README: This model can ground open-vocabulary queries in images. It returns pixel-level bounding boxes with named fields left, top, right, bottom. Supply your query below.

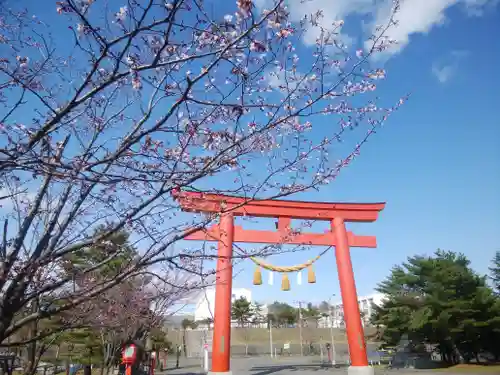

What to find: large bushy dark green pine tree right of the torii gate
left=372, top=250, right=498, bottom=363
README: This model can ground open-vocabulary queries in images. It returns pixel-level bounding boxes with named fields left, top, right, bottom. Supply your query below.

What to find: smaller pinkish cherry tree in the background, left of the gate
left=61, top=275, right=178, bottom=374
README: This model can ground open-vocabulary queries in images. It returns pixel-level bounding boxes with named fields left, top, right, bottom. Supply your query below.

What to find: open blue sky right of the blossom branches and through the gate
left=2, top=0, right=500, bottom=310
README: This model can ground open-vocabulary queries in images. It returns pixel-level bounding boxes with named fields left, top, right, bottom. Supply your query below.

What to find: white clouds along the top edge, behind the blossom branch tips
left=255, top=0, right=500, bottom=57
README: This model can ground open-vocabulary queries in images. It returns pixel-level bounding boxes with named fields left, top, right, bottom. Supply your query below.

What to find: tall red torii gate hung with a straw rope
left=173, top=191, right=385, bottom=375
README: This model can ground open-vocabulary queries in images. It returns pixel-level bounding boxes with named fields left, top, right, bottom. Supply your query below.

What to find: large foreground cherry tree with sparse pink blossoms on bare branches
left=0, top=0, right=405, bottom=352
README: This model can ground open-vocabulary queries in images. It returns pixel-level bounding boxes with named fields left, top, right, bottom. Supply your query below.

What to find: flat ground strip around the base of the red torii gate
left=162, top=356, right=500, bottom=375
